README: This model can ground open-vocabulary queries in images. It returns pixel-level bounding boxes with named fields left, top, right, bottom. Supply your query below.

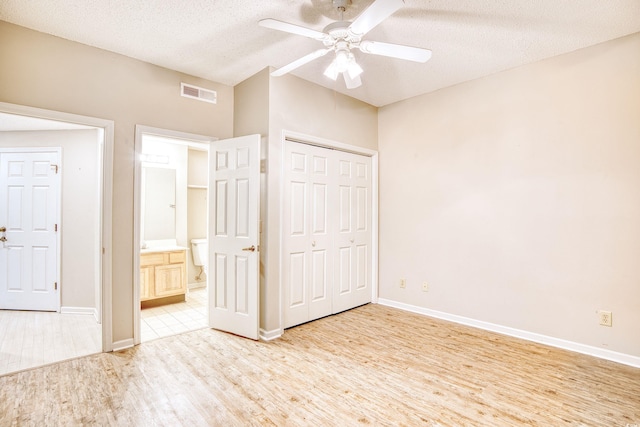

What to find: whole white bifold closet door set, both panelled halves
left=282, top=141, right=372, bottom=328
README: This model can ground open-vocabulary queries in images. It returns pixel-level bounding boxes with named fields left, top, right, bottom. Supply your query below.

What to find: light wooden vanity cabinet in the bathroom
left=140, top=250, right=187, bottom=307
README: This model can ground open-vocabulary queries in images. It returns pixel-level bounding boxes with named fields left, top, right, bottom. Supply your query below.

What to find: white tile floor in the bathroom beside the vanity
left=140, top=288, right=208, bottom=342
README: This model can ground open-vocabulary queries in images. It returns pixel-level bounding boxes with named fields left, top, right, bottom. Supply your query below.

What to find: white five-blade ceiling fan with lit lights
left=258, top=0, right=431, bottom=89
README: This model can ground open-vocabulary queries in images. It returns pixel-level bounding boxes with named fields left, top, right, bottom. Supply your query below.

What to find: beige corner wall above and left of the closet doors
left=235, top=69, right=378, bottom=332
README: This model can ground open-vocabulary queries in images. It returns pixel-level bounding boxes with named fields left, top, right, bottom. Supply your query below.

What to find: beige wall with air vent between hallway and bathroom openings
left=0, top=21, right=233, bottom=342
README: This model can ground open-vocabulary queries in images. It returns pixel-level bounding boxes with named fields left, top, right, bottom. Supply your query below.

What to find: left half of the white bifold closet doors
left=282, top=141, right=335, bottom=328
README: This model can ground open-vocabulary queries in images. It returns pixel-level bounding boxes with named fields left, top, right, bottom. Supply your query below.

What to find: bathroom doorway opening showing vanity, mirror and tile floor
left=134, top=126, right=215, bottom=344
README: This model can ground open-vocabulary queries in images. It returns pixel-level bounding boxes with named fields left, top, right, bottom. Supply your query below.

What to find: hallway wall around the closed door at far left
left=0, top=130, right=100, bottom=310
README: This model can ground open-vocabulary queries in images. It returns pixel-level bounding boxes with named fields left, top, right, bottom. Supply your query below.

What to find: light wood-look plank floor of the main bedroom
left=0, top=304, right=640, bottom=427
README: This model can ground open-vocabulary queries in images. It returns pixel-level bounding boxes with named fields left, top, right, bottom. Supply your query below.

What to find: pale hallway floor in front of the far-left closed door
left=0, top=310, right=102, bottom=375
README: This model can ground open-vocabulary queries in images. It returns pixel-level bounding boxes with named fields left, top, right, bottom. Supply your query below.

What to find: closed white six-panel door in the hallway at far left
left=0, top=148, right=61, bottom=311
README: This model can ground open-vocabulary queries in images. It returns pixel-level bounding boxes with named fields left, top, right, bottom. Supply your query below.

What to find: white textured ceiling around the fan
left=0, top=0, right=640, bottom=106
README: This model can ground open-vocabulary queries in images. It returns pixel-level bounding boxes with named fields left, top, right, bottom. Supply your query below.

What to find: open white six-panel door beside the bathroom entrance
left=208, top=135, right=260, bottom=340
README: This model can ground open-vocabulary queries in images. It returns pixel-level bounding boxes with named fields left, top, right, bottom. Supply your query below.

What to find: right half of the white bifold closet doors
left=333, top=151, right=373, bottom=313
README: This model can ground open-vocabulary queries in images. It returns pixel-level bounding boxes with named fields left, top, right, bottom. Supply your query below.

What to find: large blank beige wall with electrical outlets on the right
left=379, top=34, right=640, bottom=356
